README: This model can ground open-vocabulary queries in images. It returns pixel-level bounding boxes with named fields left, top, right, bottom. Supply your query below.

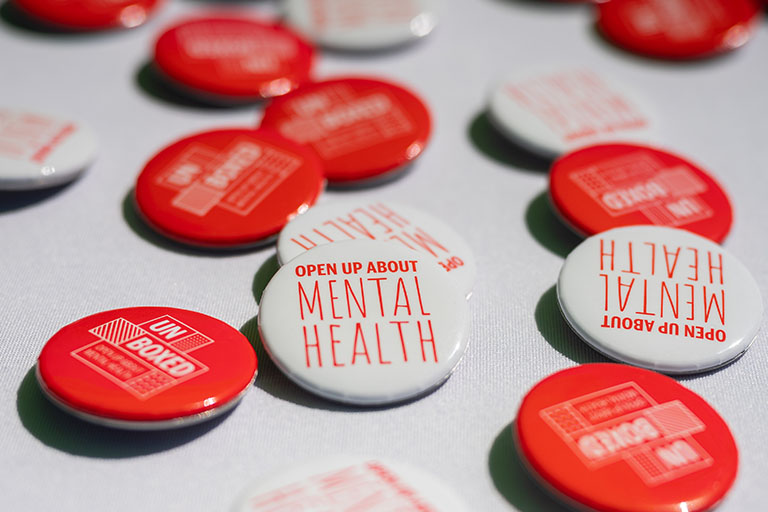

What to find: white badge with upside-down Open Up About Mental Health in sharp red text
left=557, top=226, right=763, bottom=374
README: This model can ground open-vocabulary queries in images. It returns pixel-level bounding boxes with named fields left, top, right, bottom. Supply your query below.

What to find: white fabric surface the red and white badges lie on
left=0, top=0, right=768, bottom=512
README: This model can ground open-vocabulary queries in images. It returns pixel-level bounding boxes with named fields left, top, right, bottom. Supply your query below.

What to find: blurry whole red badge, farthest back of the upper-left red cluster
left=154, top=17, right=314, bottom=100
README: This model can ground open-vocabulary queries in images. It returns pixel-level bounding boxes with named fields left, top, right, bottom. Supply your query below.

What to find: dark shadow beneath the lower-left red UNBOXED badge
left=16, top=367, right=226, bottom=459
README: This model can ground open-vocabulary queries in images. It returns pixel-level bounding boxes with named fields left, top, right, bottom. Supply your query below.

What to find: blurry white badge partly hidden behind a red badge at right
left=488, top=69, right=657, bottom=158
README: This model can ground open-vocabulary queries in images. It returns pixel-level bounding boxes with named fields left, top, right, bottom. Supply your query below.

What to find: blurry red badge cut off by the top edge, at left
left=14, top=0, right=164, bottom=30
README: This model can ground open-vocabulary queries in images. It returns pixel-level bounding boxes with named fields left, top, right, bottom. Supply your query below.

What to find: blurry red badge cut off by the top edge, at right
left=597, top=0, right=760, bottom=59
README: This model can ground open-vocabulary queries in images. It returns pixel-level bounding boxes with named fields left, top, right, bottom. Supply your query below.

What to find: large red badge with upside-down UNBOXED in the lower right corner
left=514, top=364, right=738, bottom=512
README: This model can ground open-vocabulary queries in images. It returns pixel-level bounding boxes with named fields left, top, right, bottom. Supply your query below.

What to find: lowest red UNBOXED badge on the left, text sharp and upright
left=37, top=307, right=256, bottom=430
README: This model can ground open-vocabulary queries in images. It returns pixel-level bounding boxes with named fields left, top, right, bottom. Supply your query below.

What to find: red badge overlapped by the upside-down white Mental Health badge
left=549, top=144, right=733, bottom=243
